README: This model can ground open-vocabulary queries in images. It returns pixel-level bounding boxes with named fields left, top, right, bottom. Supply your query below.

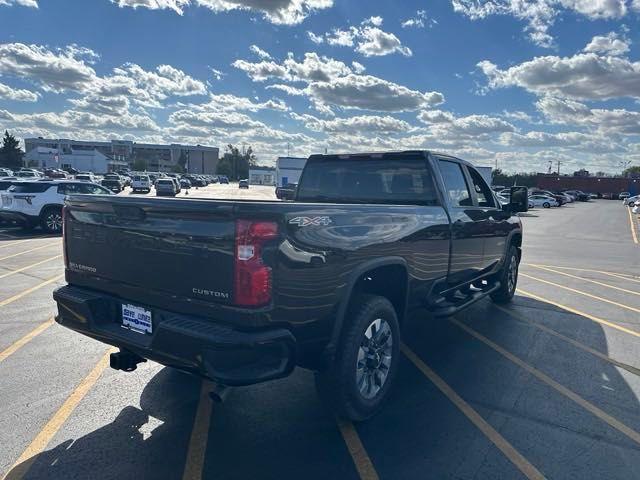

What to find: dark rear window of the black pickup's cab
left=297, top=155, right=438, bottom=205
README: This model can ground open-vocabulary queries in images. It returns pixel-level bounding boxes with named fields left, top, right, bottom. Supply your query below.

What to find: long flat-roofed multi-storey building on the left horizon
left=24, top=137, right=220, bottom=174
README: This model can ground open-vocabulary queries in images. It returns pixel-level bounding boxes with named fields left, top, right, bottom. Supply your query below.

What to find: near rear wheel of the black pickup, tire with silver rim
left=315, top=295, right=400, bottom=422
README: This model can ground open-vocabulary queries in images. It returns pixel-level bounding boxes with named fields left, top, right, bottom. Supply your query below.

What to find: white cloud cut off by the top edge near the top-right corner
left=451, top=0, right=638, bottom=47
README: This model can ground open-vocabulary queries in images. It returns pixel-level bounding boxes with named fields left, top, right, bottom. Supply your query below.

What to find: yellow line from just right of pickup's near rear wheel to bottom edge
left=400, top=344, right=545, bottom=479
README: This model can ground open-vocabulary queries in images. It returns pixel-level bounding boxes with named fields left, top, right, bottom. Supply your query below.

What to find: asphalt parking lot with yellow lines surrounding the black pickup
left=0, top=189, right=640, bottom=480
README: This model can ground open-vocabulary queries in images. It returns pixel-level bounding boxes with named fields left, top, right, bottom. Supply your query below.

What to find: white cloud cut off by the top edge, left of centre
left=116, top=0, right=333, bottom=25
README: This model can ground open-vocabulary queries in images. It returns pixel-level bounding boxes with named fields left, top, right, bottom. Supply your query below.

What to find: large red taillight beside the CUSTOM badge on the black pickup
left=234, top=220, right=278, bottom=307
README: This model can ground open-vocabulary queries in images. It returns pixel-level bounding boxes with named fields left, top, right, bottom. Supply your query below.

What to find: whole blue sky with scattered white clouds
left=0, top=0, right=640, bottom=172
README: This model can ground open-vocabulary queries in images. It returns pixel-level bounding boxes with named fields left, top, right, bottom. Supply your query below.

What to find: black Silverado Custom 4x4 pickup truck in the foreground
left=54, top=151, right=528, bottom=420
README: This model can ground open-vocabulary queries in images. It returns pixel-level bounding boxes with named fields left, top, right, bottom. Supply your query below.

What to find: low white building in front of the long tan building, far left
left=23, top=147, right=128, bottom=173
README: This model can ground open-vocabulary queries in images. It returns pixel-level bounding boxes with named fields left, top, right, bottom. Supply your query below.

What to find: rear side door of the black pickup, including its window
left=435, top=157, right=484, bottom=284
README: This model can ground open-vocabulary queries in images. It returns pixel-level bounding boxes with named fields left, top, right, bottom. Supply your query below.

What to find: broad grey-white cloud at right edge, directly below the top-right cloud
left=478, top=53, right=640, bottom=100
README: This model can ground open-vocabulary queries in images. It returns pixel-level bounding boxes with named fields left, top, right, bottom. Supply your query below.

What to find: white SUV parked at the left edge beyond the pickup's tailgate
left=0, top=181, right=111, bottom=233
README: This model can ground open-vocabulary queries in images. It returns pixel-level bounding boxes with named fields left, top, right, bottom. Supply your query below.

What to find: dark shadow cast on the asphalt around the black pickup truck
left=7, top=297, right=640, bottom=480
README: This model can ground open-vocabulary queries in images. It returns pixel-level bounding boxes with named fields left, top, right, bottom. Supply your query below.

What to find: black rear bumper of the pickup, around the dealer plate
left=53, top=286, right=296, bottom=385
